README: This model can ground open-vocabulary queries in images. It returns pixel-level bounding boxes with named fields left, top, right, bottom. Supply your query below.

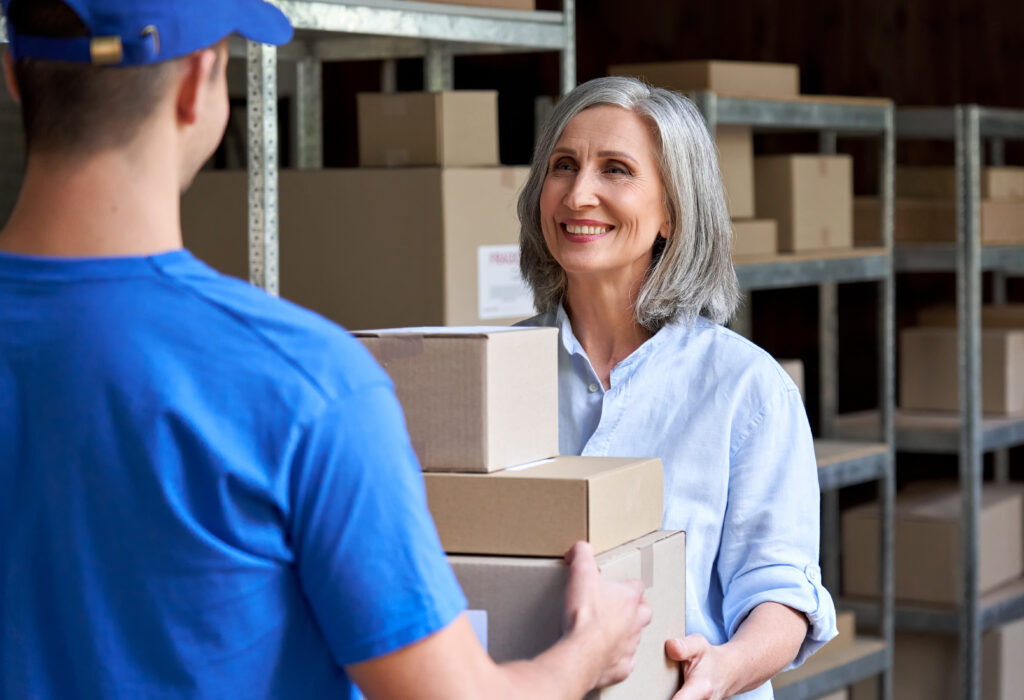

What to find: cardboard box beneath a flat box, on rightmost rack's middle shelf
left=899, top=327, right=1024, bottom=415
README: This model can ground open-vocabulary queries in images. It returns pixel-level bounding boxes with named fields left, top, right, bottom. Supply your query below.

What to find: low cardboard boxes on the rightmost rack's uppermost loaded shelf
left=854, top=167, right=1024, bottom=245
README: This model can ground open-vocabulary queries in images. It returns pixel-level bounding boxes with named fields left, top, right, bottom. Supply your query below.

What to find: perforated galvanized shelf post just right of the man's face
left=246, top=41, right=279, bottom=296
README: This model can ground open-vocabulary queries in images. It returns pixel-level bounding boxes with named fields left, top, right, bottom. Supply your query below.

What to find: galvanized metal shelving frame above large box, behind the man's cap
left=232, top=0, right=575, bottom=294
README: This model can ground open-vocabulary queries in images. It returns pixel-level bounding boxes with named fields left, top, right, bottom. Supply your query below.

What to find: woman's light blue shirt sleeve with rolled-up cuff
left=718, top=386, right=837, bottom=666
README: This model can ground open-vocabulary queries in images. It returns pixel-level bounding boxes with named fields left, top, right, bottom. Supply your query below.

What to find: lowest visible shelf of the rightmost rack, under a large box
left=840, top=578, right=1024, bottom=635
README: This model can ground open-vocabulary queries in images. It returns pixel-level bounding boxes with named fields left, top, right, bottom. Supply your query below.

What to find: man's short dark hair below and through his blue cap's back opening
left=7, top=0, right=176, bottom=156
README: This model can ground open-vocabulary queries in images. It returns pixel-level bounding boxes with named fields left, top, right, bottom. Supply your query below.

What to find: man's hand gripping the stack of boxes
left=565, top=542, right=651, bottom=688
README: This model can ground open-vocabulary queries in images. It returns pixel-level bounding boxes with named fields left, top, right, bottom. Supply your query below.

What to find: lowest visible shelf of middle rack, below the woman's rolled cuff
left=771, top=636, right=889, bottom=700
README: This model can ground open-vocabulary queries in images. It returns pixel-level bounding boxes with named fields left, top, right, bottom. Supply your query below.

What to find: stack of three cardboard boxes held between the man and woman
left=355, top=327, right=686, bottom=700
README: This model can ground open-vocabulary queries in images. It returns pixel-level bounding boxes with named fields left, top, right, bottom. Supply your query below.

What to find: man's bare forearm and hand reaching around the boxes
left=346, top=542, right=651, bottom=700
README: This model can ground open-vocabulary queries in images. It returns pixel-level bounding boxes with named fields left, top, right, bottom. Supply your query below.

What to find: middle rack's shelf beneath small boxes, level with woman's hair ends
left=734, top=248, right=891, bottom=290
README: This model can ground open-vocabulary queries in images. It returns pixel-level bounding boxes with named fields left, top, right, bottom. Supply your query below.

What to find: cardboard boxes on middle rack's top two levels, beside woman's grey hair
left=609, top=60, right=853, bottom=256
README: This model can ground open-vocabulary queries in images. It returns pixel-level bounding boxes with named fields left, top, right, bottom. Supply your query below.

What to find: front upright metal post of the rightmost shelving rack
left=955, top=105, right=982, bottom=700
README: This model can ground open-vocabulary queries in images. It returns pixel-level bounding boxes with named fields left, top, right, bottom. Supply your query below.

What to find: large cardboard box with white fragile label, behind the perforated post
left=182, top=168, right=535, bottom=329
